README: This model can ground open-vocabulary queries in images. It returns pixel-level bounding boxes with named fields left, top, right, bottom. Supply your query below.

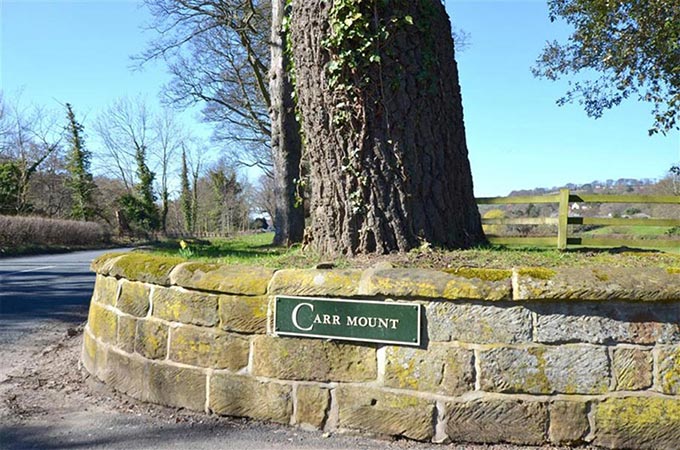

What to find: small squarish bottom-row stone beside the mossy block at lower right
left=548, top=401, right=590, bottom=445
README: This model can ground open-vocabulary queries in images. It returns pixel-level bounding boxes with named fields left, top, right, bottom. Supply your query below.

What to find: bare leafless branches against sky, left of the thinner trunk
left=136, top=0, right=272, bottom=175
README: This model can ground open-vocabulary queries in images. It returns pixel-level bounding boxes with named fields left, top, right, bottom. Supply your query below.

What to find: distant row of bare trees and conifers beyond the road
left=0, top=94, right=271, bottom=237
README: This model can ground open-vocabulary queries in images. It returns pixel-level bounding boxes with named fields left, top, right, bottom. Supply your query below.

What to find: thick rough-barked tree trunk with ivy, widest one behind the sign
left=291, top=0, right=484, bottom=254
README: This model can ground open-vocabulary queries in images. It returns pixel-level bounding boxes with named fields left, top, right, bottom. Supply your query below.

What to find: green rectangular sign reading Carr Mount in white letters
left=274, top=296, right=421, bottom=346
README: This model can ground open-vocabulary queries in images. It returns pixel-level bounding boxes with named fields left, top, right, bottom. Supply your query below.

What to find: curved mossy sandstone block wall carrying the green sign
left=83, top=254, right=680, bottom=450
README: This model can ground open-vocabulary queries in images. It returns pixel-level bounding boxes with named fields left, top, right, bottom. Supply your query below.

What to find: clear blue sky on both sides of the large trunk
left=0, top=0, right=680, bottom=196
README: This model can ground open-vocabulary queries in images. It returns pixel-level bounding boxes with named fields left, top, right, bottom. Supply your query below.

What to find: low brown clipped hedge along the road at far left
left=0, top=216, right=108, bottom=251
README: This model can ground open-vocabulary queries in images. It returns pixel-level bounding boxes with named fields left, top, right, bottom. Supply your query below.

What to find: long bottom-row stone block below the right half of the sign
left=336, top=386, right=436, bottom=441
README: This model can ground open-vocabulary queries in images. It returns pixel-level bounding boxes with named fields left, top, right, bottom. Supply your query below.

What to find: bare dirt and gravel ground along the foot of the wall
left=0, top=321, right=596, bottom=450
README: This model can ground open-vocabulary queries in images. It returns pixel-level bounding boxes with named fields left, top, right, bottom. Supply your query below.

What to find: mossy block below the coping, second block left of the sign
left=151, top=287, right=219, bottom=327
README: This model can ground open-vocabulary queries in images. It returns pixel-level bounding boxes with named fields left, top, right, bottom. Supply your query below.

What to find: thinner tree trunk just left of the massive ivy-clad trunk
left=269, top=0, right=305, bottom=246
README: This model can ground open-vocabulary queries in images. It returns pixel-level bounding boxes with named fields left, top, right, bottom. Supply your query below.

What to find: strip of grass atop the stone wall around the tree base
left=147, top=233, right=680, bottom=269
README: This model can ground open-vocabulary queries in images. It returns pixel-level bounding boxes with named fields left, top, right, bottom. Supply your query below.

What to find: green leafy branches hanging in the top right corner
left=533, top=0, right=680, bottom=135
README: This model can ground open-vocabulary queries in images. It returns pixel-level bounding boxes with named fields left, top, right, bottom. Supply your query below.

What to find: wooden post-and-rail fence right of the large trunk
left=477, top=189, right=680, bottom=250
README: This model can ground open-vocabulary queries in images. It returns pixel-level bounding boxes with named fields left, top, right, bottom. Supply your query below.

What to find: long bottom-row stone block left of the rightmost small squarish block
left=444, top=400, right=548, bottom=445
